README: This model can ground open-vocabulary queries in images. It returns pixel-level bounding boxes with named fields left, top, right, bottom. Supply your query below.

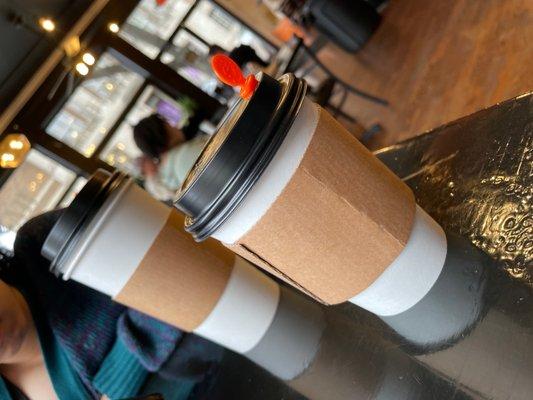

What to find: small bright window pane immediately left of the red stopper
left=161, top=30, right=218, bottom=95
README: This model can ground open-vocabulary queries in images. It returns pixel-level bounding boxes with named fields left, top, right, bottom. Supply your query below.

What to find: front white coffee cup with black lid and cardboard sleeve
left=175, top=74, right=447, bottom=316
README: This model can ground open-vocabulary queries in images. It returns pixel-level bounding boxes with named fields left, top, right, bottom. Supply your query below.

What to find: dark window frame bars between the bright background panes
left=0, top=0, right=277, bottom=180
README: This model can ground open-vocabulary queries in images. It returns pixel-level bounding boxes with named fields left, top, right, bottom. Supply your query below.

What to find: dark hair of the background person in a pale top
left=133, top=114, right=169, bottom=159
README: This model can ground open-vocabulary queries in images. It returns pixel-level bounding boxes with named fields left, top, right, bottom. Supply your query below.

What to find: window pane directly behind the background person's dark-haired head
left=100, top=86, right=195, bottom=176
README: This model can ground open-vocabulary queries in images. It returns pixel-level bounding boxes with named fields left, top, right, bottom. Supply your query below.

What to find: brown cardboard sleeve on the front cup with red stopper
left=229, top=104, right=415, bottom=304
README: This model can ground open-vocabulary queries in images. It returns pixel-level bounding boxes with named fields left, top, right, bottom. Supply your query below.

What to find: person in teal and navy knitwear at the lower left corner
left=0, top=211, right=222, bottom=400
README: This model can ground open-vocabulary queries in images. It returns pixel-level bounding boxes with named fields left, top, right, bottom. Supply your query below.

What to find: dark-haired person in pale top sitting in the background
left=133, top=114, right=209, bottom=201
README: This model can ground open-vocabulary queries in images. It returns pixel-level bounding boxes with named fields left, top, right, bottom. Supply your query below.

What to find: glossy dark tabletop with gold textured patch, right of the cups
left=210, top=94, right=533, bottom=400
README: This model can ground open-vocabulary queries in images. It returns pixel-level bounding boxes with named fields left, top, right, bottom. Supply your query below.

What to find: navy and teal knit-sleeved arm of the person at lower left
left=15, top=210, right=182, bottom=398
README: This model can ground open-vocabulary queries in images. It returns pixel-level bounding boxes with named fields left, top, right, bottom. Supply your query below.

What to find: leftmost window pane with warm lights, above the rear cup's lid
left=0, top=149, right=76, bottom=250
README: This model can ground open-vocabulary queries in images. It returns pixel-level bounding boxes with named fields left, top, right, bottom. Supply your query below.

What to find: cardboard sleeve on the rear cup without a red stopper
left=115, top=210, right=235, bottom=332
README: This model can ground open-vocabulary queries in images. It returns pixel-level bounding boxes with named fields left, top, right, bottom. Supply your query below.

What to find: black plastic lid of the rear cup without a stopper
left=41, top=169, right=127, bottom=275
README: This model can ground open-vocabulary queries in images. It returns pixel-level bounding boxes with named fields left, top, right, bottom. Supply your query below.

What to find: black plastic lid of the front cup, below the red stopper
left=175, top=74, right=307, bottom=241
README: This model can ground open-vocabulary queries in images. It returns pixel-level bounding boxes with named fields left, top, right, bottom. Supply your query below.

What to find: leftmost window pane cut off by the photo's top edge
left=119, top=0, right=194, bottom=58
